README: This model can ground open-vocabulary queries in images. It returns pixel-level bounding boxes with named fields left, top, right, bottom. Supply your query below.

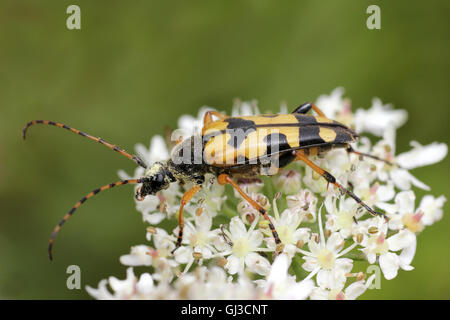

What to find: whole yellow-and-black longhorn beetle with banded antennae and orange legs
left=23, top=103, right=387, bottom=259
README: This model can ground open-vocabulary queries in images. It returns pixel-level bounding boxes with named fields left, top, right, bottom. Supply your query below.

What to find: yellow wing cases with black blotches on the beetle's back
left=203, top=113, right=357, bottom=166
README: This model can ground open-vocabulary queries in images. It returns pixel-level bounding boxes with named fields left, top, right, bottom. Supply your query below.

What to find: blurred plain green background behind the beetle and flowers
left=0, top=0, right=450, bottom=299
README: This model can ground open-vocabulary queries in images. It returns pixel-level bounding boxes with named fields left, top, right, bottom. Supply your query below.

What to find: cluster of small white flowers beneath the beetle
left=87, top=88, right=447, bottom=299
